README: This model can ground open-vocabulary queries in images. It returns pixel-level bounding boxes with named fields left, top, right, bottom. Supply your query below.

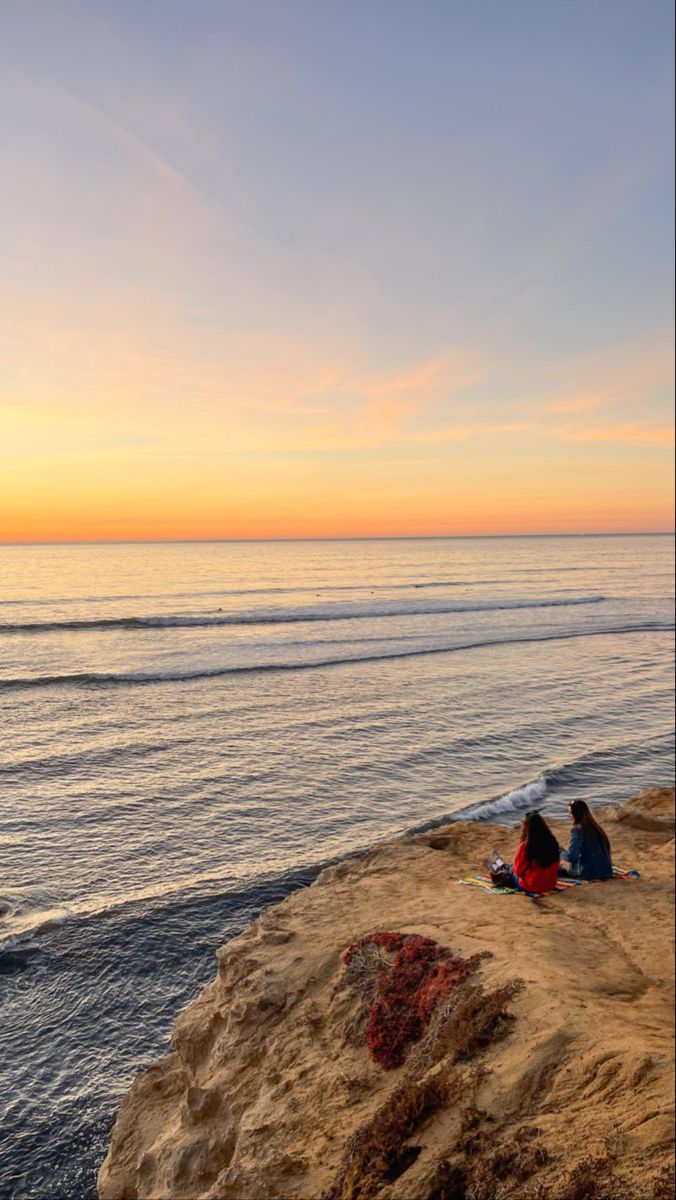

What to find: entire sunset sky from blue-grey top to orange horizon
left=0, top=0, right=674, bottom=541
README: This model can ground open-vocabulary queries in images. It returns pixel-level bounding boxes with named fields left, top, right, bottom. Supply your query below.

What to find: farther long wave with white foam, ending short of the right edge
left=0, top=584, right=605, bottom=634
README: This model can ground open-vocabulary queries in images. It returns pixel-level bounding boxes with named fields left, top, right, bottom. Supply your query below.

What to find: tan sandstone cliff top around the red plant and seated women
left=98, top=788, right=674, bottom=1200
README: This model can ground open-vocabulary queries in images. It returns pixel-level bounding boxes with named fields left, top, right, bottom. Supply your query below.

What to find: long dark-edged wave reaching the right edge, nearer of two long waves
left=0, top=622, right=674, bottom=691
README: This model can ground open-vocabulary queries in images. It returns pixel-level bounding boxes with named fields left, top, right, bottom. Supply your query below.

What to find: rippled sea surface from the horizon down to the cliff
left=0, top=536, right=674, bottom=1200
